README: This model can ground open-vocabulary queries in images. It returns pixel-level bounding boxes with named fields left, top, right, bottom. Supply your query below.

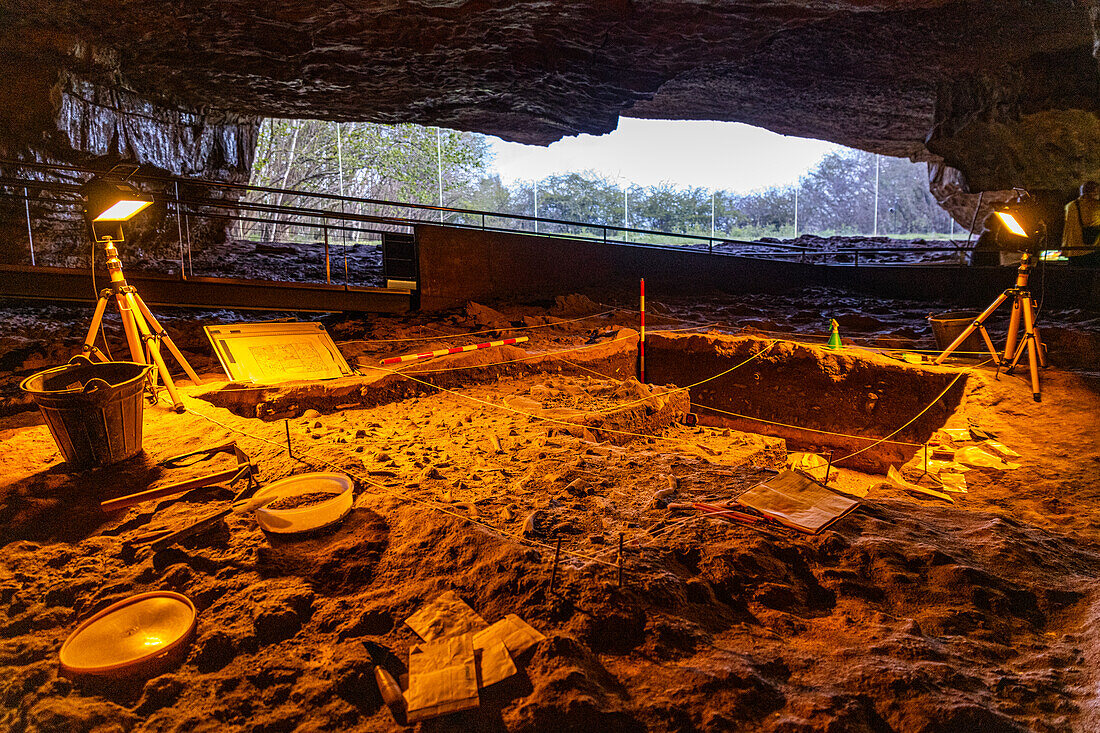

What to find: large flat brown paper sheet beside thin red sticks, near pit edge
left=737, top=471, right=859, bottom=534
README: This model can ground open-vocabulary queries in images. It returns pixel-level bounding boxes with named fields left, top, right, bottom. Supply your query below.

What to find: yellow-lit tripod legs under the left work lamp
left=80, top=237, right=200, bottom=413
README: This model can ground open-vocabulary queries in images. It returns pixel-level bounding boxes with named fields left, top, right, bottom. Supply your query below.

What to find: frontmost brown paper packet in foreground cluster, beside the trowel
left=405, top=633, right=481, bottom=723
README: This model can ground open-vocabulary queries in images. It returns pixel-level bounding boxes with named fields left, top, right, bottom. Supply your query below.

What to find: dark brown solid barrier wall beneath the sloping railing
left=417, top=225, right=1100, bottom=310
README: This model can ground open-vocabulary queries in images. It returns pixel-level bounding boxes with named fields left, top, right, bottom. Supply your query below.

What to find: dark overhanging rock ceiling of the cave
left=0, top=0, right=1100, bottom=190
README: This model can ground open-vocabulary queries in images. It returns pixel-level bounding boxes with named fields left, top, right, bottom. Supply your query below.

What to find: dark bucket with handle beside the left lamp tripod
left=19, top=357, right=153, bottom=469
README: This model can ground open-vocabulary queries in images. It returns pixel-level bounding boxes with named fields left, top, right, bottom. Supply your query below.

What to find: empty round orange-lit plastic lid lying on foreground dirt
left=61, top=591, right=197, bottom=677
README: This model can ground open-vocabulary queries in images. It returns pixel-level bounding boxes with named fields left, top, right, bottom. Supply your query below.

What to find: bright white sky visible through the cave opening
left=488, top=118, right=845, bottom=193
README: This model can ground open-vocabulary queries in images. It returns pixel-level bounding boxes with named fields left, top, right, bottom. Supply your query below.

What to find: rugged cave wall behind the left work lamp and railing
left=0, top=52, right=259, bottom=272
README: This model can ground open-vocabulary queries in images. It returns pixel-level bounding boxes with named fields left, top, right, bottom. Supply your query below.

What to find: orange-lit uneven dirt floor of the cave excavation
left=0, top=293, right=1100, bottom=731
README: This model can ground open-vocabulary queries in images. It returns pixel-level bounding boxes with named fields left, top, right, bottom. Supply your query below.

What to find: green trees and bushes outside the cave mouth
left=252, top=120, right=950, bottom=243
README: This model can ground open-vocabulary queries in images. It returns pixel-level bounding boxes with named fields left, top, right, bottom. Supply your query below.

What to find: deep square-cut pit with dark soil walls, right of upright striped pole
left=646, top=335, right=966, bottom=472
